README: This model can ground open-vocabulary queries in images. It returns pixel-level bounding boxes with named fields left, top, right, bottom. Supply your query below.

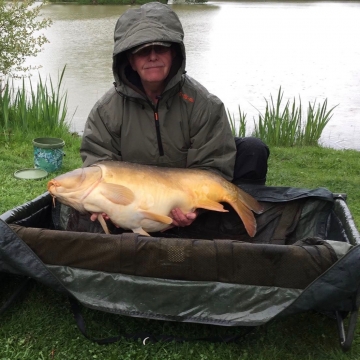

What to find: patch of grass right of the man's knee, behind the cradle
left=267, top=146, right=360, bottom=222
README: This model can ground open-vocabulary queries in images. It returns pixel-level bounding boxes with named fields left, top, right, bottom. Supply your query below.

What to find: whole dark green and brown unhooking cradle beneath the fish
left=0, top=186, right=360, bottom=349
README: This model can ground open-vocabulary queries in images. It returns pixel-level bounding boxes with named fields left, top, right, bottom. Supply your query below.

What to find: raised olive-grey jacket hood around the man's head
left=113, top=2, right=186, bottom=96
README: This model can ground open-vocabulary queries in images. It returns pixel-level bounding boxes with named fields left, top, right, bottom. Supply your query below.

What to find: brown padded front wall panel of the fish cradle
left=10, top=225, right=337, bottom=289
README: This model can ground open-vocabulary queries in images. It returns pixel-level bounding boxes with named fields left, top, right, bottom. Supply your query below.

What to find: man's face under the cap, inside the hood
left=129, top=45, right=175, bottom=86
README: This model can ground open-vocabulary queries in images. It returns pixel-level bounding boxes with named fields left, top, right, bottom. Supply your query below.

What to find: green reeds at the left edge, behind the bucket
left=0, top=67, right=70, bottom=140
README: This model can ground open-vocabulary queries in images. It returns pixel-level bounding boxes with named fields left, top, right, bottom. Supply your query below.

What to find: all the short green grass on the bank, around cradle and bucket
left=0, top=78, right=360, bottom=360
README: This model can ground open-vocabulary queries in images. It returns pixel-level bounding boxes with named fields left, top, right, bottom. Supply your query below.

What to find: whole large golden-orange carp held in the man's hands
left=47, top=161, right=263, bottom=237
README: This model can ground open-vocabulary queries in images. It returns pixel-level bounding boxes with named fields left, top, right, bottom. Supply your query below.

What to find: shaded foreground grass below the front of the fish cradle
left=0, top=280, right=359, bottom=360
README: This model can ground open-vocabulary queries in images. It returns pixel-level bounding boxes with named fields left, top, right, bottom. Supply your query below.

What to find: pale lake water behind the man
left=26, top=1, right=360, bottom=150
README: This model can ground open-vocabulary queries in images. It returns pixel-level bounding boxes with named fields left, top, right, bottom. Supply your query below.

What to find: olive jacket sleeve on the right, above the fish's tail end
left=187, top=93, right=236, bottom=181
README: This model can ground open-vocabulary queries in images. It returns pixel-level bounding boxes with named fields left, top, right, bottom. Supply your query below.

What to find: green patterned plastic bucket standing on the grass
left=33, top=138, right=65, bottom=172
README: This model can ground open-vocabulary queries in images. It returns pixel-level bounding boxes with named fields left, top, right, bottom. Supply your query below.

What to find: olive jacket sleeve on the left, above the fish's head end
left=80, top=91, right=122, bottom=167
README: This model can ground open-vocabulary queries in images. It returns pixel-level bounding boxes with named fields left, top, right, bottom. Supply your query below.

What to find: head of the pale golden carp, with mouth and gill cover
left=47, top=166, right=102, bottom=212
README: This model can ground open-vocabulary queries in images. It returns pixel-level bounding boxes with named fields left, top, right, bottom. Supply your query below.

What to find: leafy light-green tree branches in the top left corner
left=0, top=0, right=51, bottom=80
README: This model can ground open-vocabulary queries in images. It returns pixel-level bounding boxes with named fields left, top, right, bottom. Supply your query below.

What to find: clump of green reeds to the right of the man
left=228, top=87, right=337, bottom=146
